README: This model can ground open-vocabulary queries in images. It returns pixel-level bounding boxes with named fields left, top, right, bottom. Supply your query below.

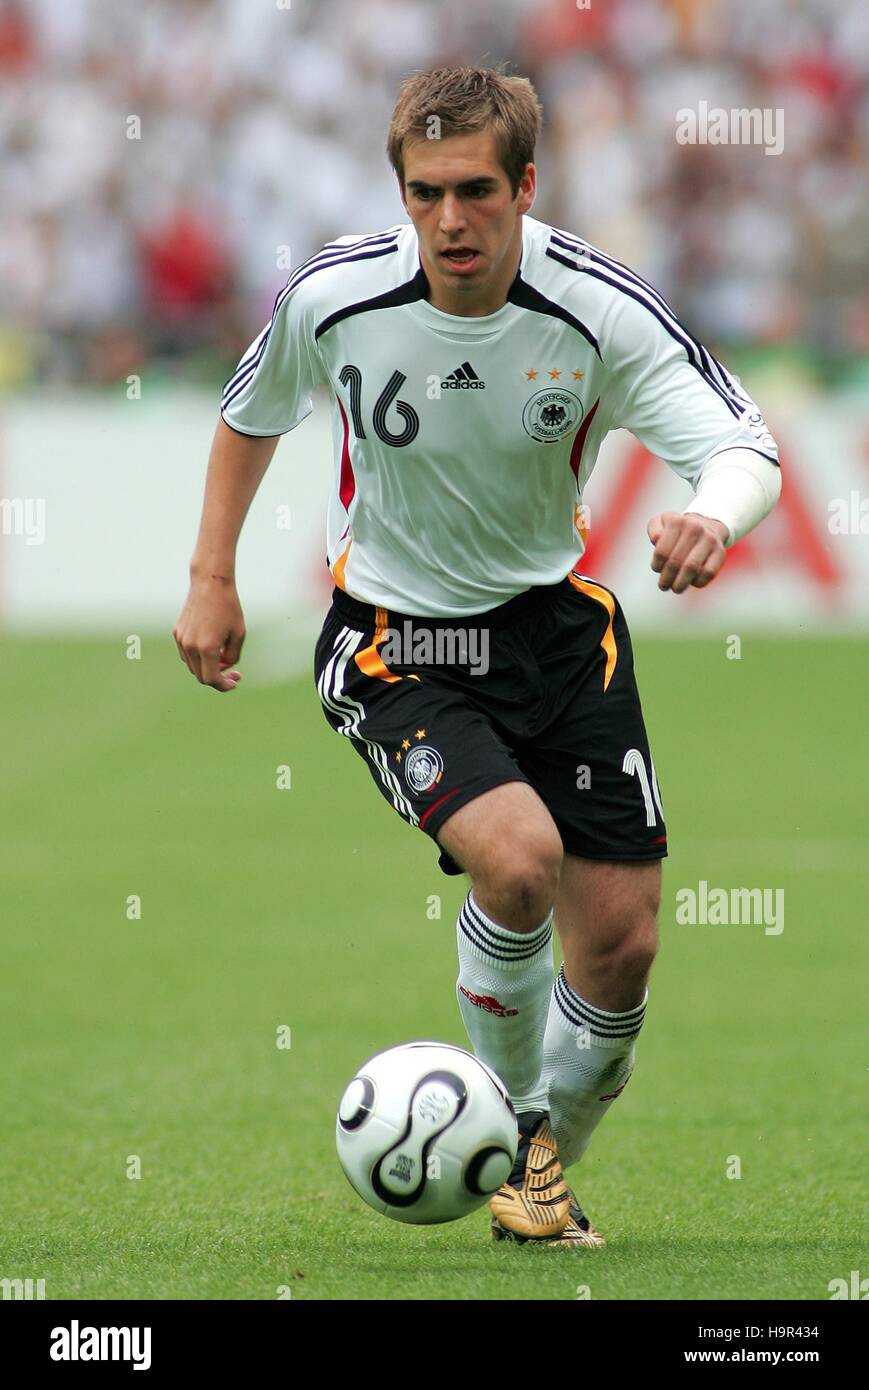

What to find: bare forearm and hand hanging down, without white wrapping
left=172, top=420, right=279, bottom=691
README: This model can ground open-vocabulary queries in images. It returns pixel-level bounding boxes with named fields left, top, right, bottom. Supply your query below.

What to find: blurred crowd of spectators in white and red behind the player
left=0, top=0, right=869, bottom=388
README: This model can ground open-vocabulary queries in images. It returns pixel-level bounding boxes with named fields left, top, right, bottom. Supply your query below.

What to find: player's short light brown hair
left=387, top=68, right=542, bottom=197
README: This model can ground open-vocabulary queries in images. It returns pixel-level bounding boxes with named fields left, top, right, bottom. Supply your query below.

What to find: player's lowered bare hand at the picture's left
left=172, top=575, right=245, bottom=692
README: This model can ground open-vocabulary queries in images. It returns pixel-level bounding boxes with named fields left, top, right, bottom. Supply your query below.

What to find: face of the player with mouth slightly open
left=402, top=131, right=537, bottom=316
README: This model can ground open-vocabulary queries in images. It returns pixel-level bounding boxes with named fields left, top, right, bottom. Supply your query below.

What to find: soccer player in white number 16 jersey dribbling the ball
left=174, top=68, right=780, bottom=1248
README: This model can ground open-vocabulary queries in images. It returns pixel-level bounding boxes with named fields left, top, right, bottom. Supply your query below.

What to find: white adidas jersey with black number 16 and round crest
left=222, top=215, right=777, bottom=617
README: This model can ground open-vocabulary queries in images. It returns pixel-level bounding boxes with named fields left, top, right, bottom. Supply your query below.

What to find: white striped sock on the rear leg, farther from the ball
left=544, top=966, right=649, bottom=1168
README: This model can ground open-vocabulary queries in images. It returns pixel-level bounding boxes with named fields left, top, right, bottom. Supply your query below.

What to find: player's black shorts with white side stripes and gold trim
left=314, top=571, right=667, bottom=874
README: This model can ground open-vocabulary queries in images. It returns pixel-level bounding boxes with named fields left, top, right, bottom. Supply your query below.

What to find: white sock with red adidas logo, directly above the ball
left=456, top=890, right=553, bottom=1113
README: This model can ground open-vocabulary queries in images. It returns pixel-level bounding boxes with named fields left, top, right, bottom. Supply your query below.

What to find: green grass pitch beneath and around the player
left=0, top=635, right=869, bottom=1300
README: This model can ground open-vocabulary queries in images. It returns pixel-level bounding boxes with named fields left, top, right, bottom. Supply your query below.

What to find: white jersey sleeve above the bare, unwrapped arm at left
left=220, top=278, right=324, bottom=435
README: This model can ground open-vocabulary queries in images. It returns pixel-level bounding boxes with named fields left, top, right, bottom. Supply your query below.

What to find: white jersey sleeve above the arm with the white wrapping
left=602, top=291, right=779, bottom=485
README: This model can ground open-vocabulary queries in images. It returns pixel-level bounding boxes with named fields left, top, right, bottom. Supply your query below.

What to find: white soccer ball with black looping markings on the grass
left=335, top=1043, right=519, bottom=1226
